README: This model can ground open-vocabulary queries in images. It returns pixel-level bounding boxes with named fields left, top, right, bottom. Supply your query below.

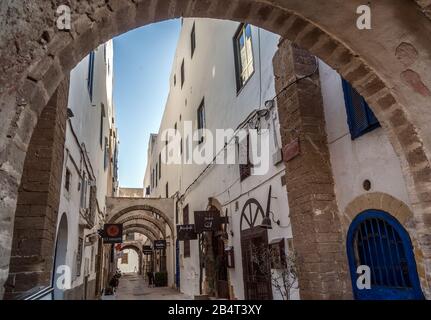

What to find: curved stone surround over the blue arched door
left=341, top=192, right=429, bottom=296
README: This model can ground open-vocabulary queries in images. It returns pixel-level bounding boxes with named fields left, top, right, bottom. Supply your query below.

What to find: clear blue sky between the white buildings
left=114, top=19, right=181, bottom=188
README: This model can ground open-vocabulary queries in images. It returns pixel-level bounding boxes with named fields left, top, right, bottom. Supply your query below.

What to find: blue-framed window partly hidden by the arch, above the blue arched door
left=342, top=79, right=380, bottom=140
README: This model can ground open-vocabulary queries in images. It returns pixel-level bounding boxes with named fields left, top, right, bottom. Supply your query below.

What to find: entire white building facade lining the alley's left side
left=55, top=40, right=118, bottom=299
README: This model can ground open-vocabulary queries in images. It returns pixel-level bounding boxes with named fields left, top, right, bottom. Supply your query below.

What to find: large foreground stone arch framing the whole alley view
left=0, top=0, right=431, bottom=295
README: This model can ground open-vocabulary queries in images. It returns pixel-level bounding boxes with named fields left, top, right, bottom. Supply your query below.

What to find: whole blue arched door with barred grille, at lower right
left=347, top=210, right=424, bottom=300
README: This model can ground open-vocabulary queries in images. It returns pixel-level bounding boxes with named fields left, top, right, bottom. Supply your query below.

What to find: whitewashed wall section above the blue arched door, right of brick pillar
left=319, top=61, right=411, bottom=213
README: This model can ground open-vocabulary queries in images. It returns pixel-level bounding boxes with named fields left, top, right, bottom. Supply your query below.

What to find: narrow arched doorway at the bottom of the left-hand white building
left=53, top=213, right=71, bottom=300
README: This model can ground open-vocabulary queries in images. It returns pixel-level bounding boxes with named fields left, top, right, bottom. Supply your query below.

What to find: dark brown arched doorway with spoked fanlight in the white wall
left=240, top=198, right=272, bottom=300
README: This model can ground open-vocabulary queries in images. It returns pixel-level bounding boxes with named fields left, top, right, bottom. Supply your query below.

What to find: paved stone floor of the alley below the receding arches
left=106, top=274, right=192, bottom=300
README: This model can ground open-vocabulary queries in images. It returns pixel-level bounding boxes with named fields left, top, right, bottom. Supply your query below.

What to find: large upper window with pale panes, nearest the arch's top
left=234, top=24, right=254, bottom=92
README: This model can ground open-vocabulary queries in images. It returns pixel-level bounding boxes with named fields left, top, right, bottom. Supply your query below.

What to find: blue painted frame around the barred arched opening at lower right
left=346, top=209, right=424, bottom=300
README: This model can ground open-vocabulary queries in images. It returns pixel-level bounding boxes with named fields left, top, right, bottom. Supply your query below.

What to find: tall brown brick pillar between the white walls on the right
left=273, top=40, right=352, bottom=299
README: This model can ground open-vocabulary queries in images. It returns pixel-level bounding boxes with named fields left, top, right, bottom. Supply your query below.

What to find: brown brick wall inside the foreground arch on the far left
left=5, top=79, right=69, bottom=298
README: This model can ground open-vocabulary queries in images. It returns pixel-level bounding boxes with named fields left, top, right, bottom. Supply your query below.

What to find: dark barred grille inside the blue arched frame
left=354, top=218, right=412, bottom=288
